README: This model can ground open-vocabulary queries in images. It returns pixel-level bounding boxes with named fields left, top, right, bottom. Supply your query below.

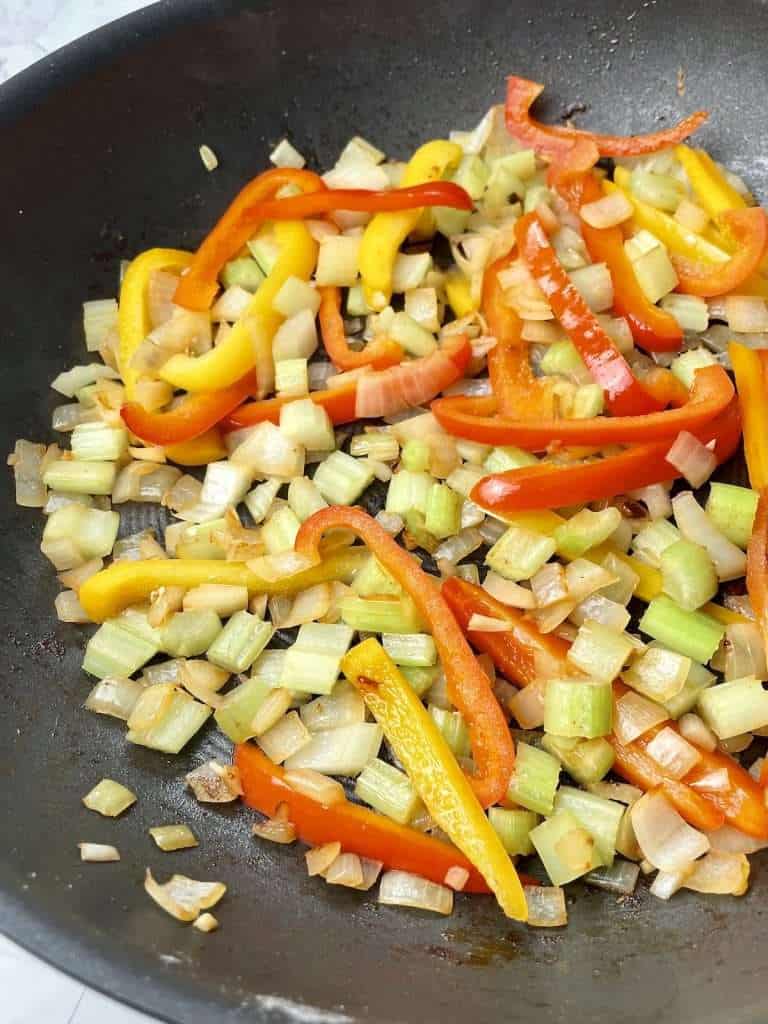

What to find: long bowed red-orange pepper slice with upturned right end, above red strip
left=432, top=367, right=733, bottom=452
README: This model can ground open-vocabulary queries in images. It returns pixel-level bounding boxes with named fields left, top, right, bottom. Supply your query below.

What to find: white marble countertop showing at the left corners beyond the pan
left=0, top=8, right=159, bottom=1024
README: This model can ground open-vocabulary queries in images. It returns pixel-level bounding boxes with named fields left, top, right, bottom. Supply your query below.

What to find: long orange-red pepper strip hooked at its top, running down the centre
left=295, top=506, right=515, bottom=807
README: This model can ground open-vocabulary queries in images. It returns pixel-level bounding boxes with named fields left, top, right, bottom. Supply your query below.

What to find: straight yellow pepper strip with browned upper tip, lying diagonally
left=342, top=639, right=527, bottom=921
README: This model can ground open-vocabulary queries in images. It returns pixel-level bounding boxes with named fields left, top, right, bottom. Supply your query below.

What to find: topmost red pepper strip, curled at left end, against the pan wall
left=506, top=75, right=709, bottom=163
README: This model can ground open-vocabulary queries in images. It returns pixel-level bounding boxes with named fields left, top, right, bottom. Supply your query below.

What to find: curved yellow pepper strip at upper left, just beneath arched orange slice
left=160, top=220, right=317, bottom=397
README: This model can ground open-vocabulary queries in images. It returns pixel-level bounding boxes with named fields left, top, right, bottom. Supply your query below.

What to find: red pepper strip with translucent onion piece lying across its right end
left=470, top=401, right=740, bottom=518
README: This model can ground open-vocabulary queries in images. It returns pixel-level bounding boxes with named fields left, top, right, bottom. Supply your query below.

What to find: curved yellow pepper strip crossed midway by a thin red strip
left=359, top=139, right=462, bottom=309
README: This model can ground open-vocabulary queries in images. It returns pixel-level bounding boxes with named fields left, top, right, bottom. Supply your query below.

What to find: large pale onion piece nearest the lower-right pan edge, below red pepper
left=630, top=792, right=710, bottom=871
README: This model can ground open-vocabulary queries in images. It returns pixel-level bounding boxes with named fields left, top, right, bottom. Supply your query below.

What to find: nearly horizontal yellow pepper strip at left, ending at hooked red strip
left=80, top=548, right=368, bottom=623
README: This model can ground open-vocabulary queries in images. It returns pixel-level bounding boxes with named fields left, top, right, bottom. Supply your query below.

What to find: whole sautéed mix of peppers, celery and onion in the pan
left=9, top=77, right=768, bottom=931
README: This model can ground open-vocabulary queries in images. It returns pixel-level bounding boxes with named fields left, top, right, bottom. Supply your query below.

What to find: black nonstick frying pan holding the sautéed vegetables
left=0, top=0, right=768, bottom=1024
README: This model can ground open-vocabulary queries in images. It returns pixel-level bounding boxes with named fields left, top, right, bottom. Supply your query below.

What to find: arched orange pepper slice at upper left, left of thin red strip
left=173, top=167, right=326, bottom=309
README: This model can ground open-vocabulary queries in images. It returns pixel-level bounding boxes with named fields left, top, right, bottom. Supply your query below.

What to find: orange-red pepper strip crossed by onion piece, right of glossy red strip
left=559, top=174, right=683, bottom=352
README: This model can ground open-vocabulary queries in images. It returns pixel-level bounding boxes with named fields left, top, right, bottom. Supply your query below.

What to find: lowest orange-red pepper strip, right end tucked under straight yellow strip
left=234, top=743, right=489, bottom=893
